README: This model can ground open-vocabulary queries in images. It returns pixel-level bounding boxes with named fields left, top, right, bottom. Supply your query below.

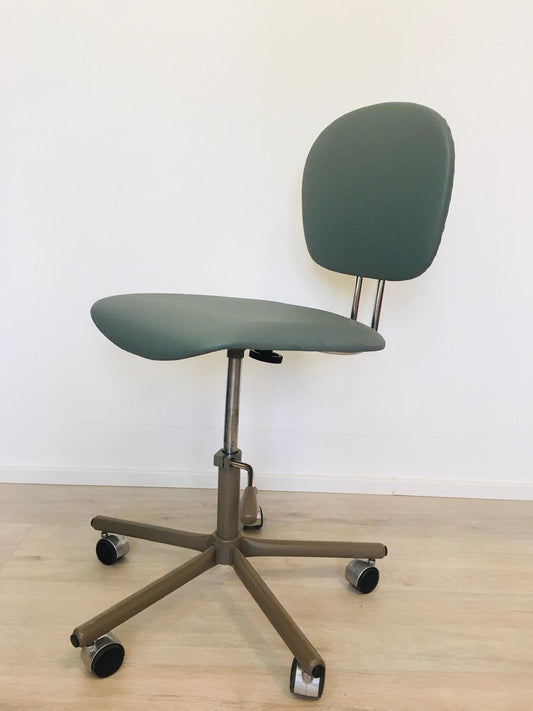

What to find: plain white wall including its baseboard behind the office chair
left=0, top=0, right=533, bottom=498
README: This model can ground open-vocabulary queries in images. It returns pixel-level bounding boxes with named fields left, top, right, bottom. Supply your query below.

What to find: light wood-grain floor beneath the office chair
left=0, top=484, right=533, bottom=711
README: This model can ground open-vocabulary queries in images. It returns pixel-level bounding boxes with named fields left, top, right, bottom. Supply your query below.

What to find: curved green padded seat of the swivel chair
left=91, top=294, right=385, bottom=360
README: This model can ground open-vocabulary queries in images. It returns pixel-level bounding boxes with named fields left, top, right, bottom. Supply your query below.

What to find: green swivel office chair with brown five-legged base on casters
left=70, top=103, right=454, bottom=699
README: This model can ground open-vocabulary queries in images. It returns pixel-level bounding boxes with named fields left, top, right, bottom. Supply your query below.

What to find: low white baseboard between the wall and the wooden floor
left=0, top=466, right=533, bottom=501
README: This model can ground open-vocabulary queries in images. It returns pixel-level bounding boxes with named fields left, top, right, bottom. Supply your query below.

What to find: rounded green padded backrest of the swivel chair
left=302, top=103, right=454, bottom=281
